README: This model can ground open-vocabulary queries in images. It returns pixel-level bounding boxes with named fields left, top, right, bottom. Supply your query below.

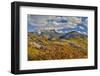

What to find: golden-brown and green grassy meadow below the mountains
left=27, top=32, right=88, bottom=61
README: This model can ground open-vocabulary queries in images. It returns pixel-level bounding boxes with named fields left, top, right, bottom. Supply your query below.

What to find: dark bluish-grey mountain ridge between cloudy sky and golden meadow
left=29, top=30, right=87, bottom=39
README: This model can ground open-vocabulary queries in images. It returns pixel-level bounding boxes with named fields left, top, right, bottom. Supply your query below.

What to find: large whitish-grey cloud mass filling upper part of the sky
left=28, top=15, right=81, bottom=30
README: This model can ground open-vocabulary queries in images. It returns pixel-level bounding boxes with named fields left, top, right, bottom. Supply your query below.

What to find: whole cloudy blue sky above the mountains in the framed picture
left=28, top=15, right=88, bottom=34
